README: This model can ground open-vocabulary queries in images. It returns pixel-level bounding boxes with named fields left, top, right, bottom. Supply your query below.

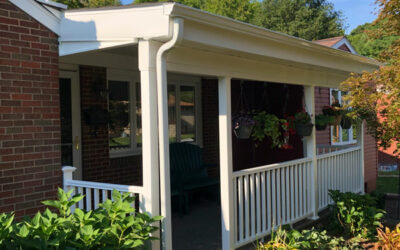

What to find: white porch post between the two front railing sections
left=304, top=86, right=318, bottom=220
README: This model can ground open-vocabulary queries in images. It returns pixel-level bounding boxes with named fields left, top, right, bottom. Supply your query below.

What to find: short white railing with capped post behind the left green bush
left=62, top=167, right=144, bottom=211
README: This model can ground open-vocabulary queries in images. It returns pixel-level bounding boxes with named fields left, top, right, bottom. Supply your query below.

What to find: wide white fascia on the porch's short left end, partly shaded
left=59, top=4, right=170, bottom=56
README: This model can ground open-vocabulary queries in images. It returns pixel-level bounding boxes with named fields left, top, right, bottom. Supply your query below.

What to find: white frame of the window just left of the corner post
left=107, top=69, right=142, bottom=158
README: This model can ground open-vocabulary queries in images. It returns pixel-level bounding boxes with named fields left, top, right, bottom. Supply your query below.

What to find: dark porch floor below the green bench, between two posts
left=172, top=193, right=221, bottom=250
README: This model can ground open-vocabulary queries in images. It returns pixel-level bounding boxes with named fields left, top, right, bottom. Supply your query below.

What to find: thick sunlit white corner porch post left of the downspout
left=138, top=40, right=160, bottom=250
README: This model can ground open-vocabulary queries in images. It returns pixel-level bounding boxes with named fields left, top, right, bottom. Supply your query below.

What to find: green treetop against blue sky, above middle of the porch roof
left=254, top=0, right=344, bottom=40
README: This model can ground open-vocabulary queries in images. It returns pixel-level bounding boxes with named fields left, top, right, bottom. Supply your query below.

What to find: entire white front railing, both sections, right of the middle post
left=233, top=146, right=363, bottom=248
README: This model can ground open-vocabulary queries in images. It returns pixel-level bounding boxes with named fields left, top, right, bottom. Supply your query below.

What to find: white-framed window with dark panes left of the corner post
left=108, top=70, right=142, bottom=157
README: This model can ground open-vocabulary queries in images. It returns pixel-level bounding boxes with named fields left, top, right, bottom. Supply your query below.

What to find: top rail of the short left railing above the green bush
left=65, top=180, right=144, bottom=194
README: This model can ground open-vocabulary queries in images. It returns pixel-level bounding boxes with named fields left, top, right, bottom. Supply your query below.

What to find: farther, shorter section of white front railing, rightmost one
left=317, top=146, right=364, bottom=210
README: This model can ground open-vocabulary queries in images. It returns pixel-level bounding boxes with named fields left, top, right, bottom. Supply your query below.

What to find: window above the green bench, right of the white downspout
left=168, top=80, right=201, bottom=145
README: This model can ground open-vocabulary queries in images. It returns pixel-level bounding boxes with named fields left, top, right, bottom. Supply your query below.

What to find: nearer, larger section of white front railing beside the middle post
left=233, top=158, right=314, bottom=247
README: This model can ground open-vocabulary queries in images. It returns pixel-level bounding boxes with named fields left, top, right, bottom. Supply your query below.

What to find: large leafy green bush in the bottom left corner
left=0, top=189, right=161, bottom=249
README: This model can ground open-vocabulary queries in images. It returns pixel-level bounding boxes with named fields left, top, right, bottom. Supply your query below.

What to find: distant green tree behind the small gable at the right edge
left=347, top=22, right=400, bottom=59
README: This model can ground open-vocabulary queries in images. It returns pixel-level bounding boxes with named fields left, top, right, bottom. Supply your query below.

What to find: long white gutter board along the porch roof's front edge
left=170, top=3, right=381, bottom=68
